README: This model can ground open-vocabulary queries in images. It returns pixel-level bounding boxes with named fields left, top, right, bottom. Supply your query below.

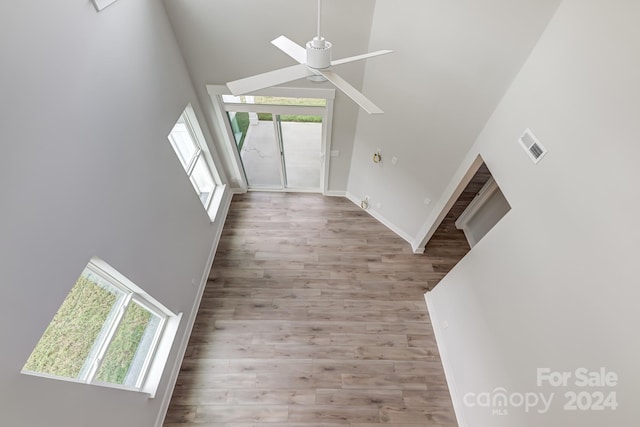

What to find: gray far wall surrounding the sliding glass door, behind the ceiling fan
left=165, top=0, right=375, bottom=193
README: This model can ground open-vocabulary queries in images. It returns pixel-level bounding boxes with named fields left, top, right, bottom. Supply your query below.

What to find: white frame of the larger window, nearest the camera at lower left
left=21, top=257, right=182, bottom=398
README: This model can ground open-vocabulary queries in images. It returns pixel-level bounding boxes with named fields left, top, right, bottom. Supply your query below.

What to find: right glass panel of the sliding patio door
left=278, top=116, right=323, bottom=190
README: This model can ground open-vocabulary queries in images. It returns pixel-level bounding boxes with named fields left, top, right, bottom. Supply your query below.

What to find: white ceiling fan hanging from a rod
left=227, top=0, right=393, bottom=114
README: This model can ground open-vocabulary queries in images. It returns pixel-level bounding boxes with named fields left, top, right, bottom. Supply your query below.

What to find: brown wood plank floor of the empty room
left=165, top=193, right=457, bottom=427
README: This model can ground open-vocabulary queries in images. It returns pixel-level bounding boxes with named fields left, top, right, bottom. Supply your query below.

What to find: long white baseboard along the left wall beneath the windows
left=155, top=190, right=234, bottom=427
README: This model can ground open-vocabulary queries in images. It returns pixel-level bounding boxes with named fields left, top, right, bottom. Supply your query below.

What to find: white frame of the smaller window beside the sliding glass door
left=167, top=104, right=225, bottom=221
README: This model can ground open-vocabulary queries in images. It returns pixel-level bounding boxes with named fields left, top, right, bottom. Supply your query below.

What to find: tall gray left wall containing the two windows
left=0, top=0, right=230, bottom=427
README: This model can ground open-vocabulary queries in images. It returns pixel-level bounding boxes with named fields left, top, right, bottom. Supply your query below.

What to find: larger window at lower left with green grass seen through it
left=23, top=260, right=169, bottom=390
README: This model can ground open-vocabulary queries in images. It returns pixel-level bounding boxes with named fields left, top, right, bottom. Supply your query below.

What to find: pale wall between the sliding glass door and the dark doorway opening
left=348, top=0, right=559, bottom=240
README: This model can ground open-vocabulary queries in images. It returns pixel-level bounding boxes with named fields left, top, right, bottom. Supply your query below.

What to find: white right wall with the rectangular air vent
left=427, top=0, right=640, bottom=427
